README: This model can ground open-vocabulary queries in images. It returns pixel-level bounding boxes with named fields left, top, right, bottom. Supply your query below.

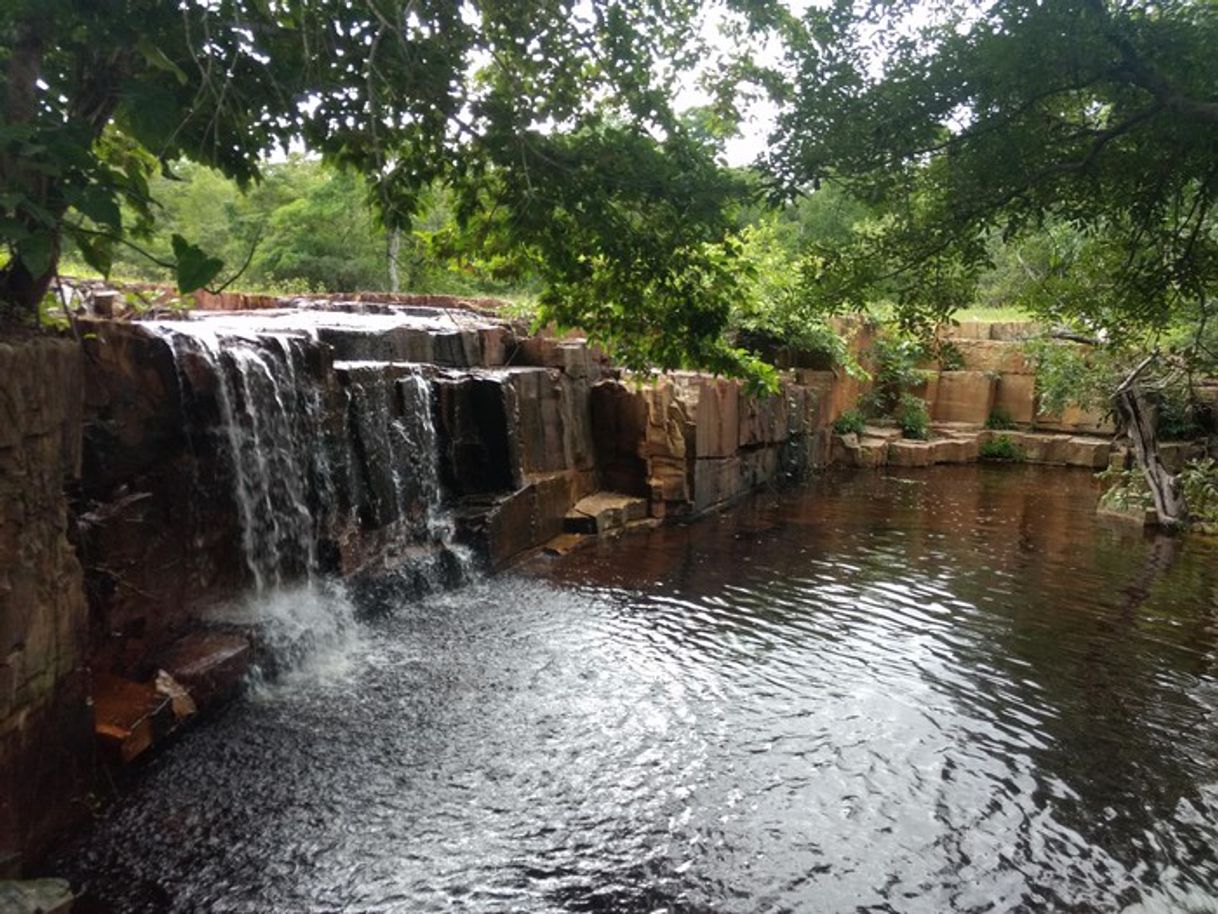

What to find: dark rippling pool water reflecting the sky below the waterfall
left=54, top=468, right=1218, bottom=913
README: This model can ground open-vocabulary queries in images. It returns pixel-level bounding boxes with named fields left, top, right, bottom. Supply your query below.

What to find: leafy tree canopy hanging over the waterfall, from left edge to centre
left=0, top=0, right=769, bottom=375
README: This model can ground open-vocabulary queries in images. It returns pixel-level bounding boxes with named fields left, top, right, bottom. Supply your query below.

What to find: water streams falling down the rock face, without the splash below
left=151, top=323, right=467, bottom=592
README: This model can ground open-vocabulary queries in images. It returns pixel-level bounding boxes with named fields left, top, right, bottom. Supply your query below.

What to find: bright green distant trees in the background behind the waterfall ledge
left=63, top=156, right=531, bottom=295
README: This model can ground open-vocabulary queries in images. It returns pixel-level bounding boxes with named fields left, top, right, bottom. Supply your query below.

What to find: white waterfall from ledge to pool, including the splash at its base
left=149, top=319, right=469, bottom=670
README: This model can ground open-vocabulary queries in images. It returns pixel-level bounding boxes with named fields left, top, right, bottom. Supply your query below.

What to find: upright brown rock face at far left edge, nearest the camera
left=0, top=339, right=93, bottom=875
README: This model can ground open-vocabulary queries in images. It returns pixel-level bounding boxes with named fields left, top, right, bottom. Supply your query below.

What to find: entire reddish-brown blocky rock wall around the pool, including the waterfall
left=0, top=309, right=1149, bottom=870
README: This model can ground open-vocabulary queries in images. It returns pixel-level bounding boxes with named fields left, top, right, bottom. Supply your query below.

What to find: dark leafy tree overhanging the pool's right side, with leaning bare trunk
left=770, top=0, right=1218, bottom=525
